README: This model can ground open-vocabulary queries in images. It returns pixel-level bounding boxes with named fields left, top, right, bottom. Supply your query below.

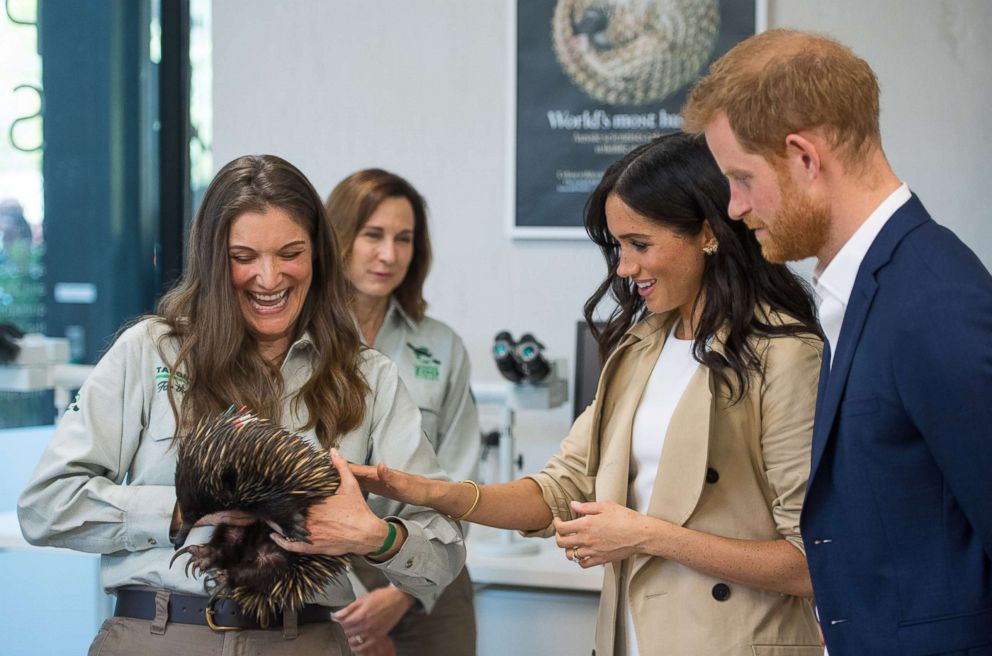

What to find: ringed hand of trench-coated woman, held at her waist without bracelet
left=554, top=501, right=660, bottom=567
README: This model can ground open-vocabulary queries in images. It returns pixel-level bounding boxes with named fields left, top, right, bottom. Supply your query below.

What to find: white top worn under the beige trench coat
left=627, top=322, right=700, bottom=656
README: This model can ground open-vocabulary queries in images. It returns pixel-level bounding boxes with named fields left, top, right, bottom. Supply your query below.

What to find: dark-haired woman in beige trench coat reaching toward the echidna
left=354, top=134, right=822, bottom=656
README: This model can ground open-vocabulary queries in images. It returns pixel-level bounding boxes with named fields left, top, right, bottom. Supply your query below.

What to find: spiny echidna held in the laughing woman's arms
left=172, top=408, right=345, bottom=627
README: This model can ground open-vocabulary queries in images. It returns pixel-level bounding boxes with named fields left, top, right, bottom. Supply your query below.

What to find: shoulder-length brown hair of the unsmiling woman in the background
left=325, top=169, right=431, bottom=321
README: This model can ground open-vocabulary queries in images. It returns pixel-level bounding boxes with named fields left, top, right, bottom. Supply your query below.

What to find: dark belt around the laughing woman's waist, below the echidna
left=114, top=588, right=332, bottom=630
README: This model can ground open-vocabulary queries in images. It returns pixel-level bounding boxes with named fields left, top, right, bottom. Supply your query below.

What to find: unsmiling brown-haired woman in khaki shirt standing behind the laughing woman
left=326, top=169, right=481, bottom=656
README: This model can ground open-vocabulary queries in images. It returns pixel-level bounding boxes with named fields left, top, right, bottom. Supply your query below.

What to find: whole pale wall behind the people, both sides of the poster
left=213, top=0, right=992, bottom=452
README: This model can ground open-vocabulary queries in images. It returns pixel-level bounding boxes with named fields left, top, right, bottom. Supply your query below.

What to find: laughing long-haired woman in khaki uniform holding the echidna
left=18, top=155, right=464, bottom=656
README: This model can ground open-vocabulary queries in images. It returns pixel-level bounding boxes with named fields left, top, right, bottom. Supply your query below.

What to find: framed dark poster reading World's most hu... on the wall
left=507, top=0, right=767, bottom=239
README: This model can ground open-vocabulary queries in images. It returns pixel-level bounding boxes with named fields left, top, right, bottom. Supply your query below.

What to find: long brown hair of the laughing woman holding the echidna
left=158, top=155, right=369, bottom=446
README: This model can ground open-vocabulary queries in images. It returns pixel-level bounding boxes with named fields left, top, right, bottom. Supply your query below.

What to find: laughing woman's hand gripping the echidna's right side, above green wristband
left=271, top=449, right=402, bottom=556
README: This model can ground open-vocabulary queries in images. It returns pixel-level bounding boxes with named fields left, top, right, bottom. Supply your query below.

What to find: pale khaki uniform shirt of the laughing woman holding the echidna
left=18, top=319, right=465, bottom=609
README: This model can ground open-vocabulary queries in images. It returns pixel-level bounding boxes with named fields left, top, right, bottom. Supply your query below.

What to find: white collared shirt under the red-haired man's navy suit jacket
left=813, top=183, right=912, bottom=364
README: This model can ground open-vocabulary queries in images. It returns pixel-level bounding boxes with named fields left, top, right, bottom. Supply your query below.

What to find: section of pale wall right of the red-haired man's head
left=769, top=0, right=992, bottom=258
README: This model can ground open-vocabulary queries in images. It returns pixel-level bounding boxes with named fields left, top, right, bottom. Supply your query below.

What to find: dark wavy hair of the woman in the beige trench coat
left=584, top=132, right=822, bottom=402
